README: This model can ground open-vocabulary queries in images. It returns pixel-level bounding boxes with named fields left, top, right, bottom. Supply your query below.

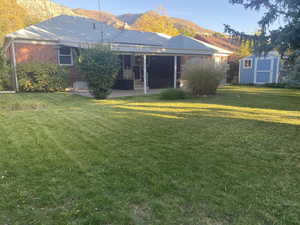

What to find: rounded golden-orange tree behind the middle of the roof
left=134, top=11, right=179, bottom=36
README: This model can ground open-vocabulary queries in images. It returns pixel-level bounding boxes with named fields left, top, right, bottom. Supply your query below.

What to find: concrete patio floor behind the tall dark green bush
left=73, top=89, right=164, bottom=98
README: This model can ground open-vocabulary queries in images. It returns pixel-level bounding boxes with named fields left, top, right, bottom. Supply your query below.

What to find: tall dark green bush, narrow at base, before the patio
left=77, top=46, right=120, bottom=99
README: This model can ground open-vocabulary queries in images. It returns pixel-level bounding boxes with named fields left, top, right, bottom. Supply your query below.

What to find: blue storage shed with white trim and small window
left=239, top=51, right=281, bottom=84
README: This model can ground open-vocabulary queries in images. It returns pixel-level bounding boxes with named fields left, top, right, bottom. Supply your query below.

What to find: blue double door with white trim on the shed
left=255, top=59, right=274, bottom=84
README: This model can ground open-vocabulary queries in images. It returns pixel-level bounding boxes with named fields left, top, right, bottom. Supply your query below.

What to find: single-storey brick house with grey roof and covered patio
left=4, top=15, right=232, bottom=93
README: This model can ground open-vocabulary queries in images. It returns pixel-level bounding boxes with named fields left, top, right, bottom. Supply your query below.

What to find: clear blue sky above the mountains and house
left=54, top=0, right=263, bottom=33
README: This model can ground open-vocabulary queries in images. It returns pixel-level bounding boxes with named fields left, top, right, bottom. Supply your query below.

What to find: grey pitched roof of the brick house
left=6, top=15, right=231, bottom=54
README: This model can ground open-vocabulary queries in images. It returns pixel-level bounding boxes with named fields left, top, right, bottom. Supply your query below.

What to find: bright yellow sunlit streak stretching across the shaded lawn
left=96, top=100, right=300, bottom=125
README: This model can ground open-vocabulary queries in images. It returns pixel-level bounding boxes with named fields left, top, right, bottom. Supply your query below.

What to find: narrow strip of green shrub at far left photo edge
left=0, top=48, right=11, bottom=91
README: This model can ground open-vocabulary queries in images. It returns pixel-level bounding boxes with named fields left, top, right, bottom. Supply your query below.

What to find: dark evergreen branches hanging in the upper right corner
left=225, top=0, right=300, bottom=56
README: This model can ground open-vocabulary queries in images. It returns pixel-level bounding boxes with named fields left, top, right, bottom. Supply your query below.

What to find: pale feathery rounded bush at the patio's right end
left=182, top=60, right=226, bottom=96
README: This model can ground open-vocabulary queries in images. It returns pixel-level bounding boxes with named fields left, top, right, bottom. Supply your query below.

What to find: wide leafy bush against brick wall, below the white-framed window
left=17, top=62, right=68, bottom=92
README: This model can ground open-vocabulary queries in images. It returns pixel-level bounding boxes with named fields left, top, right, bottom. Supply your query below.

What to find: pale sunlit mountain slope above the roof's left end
left=17, top=0, right=76, bottom=20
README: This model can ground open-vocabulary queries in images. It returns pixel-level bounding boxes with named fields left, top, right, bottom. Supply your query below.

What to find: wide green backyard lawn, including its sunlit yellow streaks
left=0, top=87, right=300, bottom=225
